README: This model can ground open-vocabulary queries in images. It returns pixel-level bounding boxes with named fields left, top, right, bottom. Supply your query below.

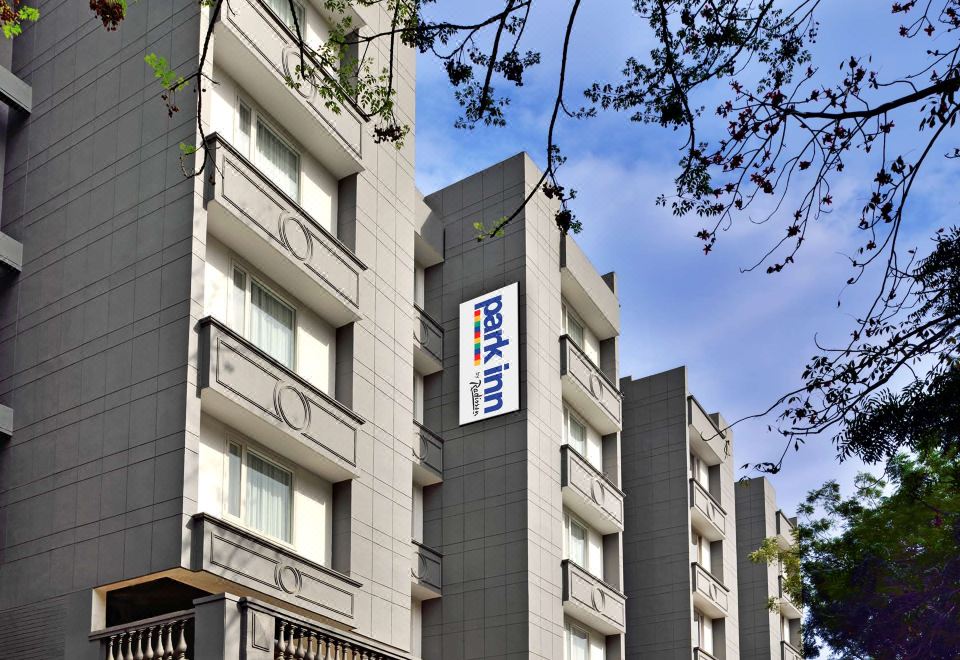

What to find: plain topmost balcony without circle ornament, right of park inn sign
left=560, top=235, right=620, bottom=339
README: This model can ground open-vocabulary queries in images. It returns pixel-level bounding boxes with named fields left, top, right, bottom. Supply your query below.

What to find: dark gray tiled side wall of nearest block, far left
left=0, top=0, right=200, bottom=658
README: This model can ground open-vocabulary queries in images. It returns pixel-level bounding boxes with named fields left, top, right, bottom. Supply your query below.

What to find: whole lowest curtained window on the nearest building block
left=226, top=442, right=293, bottom=543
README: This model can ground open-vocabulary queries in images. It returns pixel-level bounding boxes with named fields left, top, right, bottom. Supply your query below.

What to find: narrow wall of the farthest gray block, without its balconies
left=736, top=477, right=783, bottom=660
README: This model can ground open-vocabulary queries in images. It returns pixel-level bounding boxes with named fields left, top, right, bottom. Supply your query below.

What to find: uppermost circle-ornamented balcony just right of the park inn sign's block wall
left=560, top=335, right=623, bottom=435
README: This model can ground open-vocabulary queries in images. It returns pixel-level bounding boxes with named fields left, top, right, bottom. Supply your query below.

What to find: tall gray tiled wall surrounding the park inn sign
left=423, top=154, right=563, bottom=660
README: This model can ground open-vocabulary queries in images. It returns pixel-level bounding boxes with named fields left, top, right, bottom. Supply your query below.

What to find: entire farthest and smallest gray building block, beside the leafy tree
left=736, top=477, right=803, bottom=660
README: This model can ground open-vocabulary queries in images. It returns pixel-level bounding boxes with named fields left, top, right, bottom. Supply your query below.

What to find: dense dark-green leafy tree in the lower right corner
left=799, top=445, right=960, bottom=660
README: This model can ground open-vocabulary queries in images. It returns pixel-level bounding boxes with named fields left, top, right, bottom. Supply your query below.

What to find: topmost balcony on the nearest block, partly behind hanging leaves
left=214, top=0, right=366, bottom=179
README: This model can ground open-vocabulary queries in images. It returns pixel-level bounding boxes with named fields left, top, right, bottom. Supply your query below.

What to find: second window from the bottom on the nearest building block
left=229, top=266, right=296, bottom=369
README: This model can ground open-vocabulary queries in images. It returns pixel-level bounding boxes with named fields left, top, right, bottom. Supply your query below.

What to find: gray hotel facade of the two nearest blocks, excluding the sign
left=0, top=0, right=626, bottom=660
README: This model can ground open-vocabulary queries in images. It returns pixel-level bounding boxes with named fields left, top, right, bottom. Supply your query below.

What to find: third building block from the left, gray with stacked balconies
left=620, top=367, right=741, bottom=660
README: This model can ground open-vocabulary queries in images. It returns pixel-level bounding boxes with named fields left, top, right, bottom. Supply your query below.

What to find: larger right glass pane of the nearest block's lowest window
left=244, top=454, right=293, bottom=542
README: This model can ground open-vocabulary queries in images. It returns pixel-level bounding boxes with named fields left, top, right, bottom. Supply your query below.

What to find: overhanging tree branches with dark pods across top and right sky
left=9, top=0, right=960, bottom=464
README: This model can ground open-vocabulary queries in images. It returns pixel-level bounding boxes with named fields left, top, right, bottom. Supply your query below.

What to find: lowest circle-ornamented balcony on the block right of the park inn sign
left=561, top=559, right=627, bottom=635
